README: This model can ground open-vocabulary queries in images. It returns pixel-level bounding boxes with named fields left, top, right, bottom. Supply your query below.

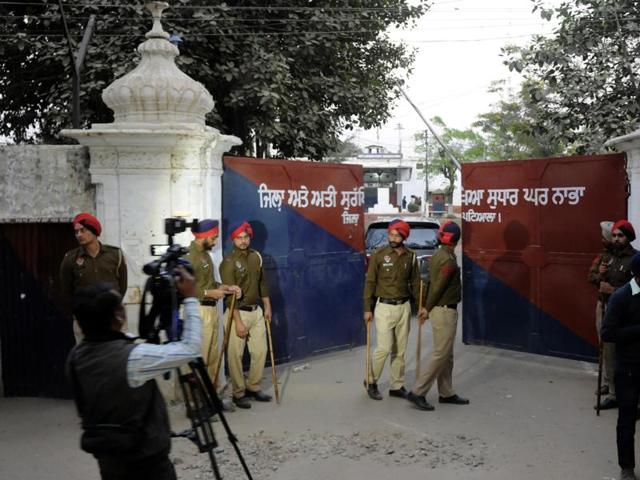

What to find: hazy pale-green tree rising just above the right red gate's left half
left=472, top=80, right=566, bottom=160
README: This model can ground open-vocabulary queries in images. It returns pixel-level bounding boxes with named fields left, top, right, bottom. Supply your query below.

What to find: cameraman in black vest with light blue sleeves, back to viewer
left=68, top=267, right=202, bottom=480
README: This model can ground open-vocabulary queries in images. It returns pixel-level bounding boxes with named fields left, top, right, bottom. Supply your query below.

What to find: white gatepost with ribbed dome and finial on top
left=62, top=2, right=241, bottom=322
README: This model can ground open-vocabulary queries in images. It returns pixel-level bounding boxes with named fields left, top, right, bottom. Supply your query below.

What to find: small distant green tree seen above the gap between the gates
left=415, top=117, right=485, bottom=202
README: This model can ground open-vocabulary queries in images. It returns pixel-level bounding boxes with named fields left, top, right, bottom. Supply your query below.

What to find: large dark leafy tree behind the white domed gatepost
left=0, top=0, right=428, bottom=159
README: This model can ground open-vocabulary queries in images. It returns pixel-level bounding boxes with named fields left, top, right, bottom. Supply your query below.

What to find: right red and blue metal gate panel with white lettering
left=462, top=154, right=628, bottom=360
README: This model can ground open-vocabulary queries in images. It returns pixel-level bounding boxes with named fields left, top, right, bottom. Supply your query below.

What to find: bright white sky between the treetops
left=348, top=0, right=559, bottom=157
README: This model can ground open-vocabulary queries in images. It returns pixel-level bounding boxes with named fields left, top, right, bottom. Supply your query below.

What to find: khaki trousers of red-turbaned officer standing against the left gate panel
left=227, top=307, right=267, bottom=398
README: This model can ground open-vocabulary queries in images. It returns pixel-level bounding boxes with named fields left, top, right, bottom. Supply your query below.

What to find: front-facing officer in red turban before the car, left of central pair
left=364, top=220, right=427, bottom=400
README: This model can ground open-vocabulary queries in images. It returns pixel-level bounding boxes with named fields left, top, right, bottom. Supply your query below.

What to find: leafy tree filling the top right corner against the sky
left=504, top=0, right=640, bottom=153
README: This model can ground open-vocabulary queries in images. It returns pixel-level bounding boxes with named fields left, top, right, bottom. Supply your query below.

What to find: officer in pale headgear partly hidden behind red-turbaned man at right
left=587, top=221, right=616, bottom=396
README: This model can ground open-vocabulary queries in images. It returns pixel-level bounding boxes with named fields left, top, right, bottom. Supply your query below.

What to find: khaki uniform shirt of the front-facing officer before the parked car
left=364, top=245, right=424, bottom=312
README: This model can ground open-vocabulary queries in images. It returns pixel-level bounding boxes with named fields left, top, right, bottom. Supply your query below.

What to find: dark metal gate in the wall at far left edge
left=0, top=223, right=76, bottom=398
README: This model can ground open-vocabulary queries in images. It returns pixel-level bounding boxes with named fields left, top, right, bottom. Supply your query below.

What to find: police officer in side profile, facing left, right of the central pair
left=407, top=221, right=469, bottom=410
